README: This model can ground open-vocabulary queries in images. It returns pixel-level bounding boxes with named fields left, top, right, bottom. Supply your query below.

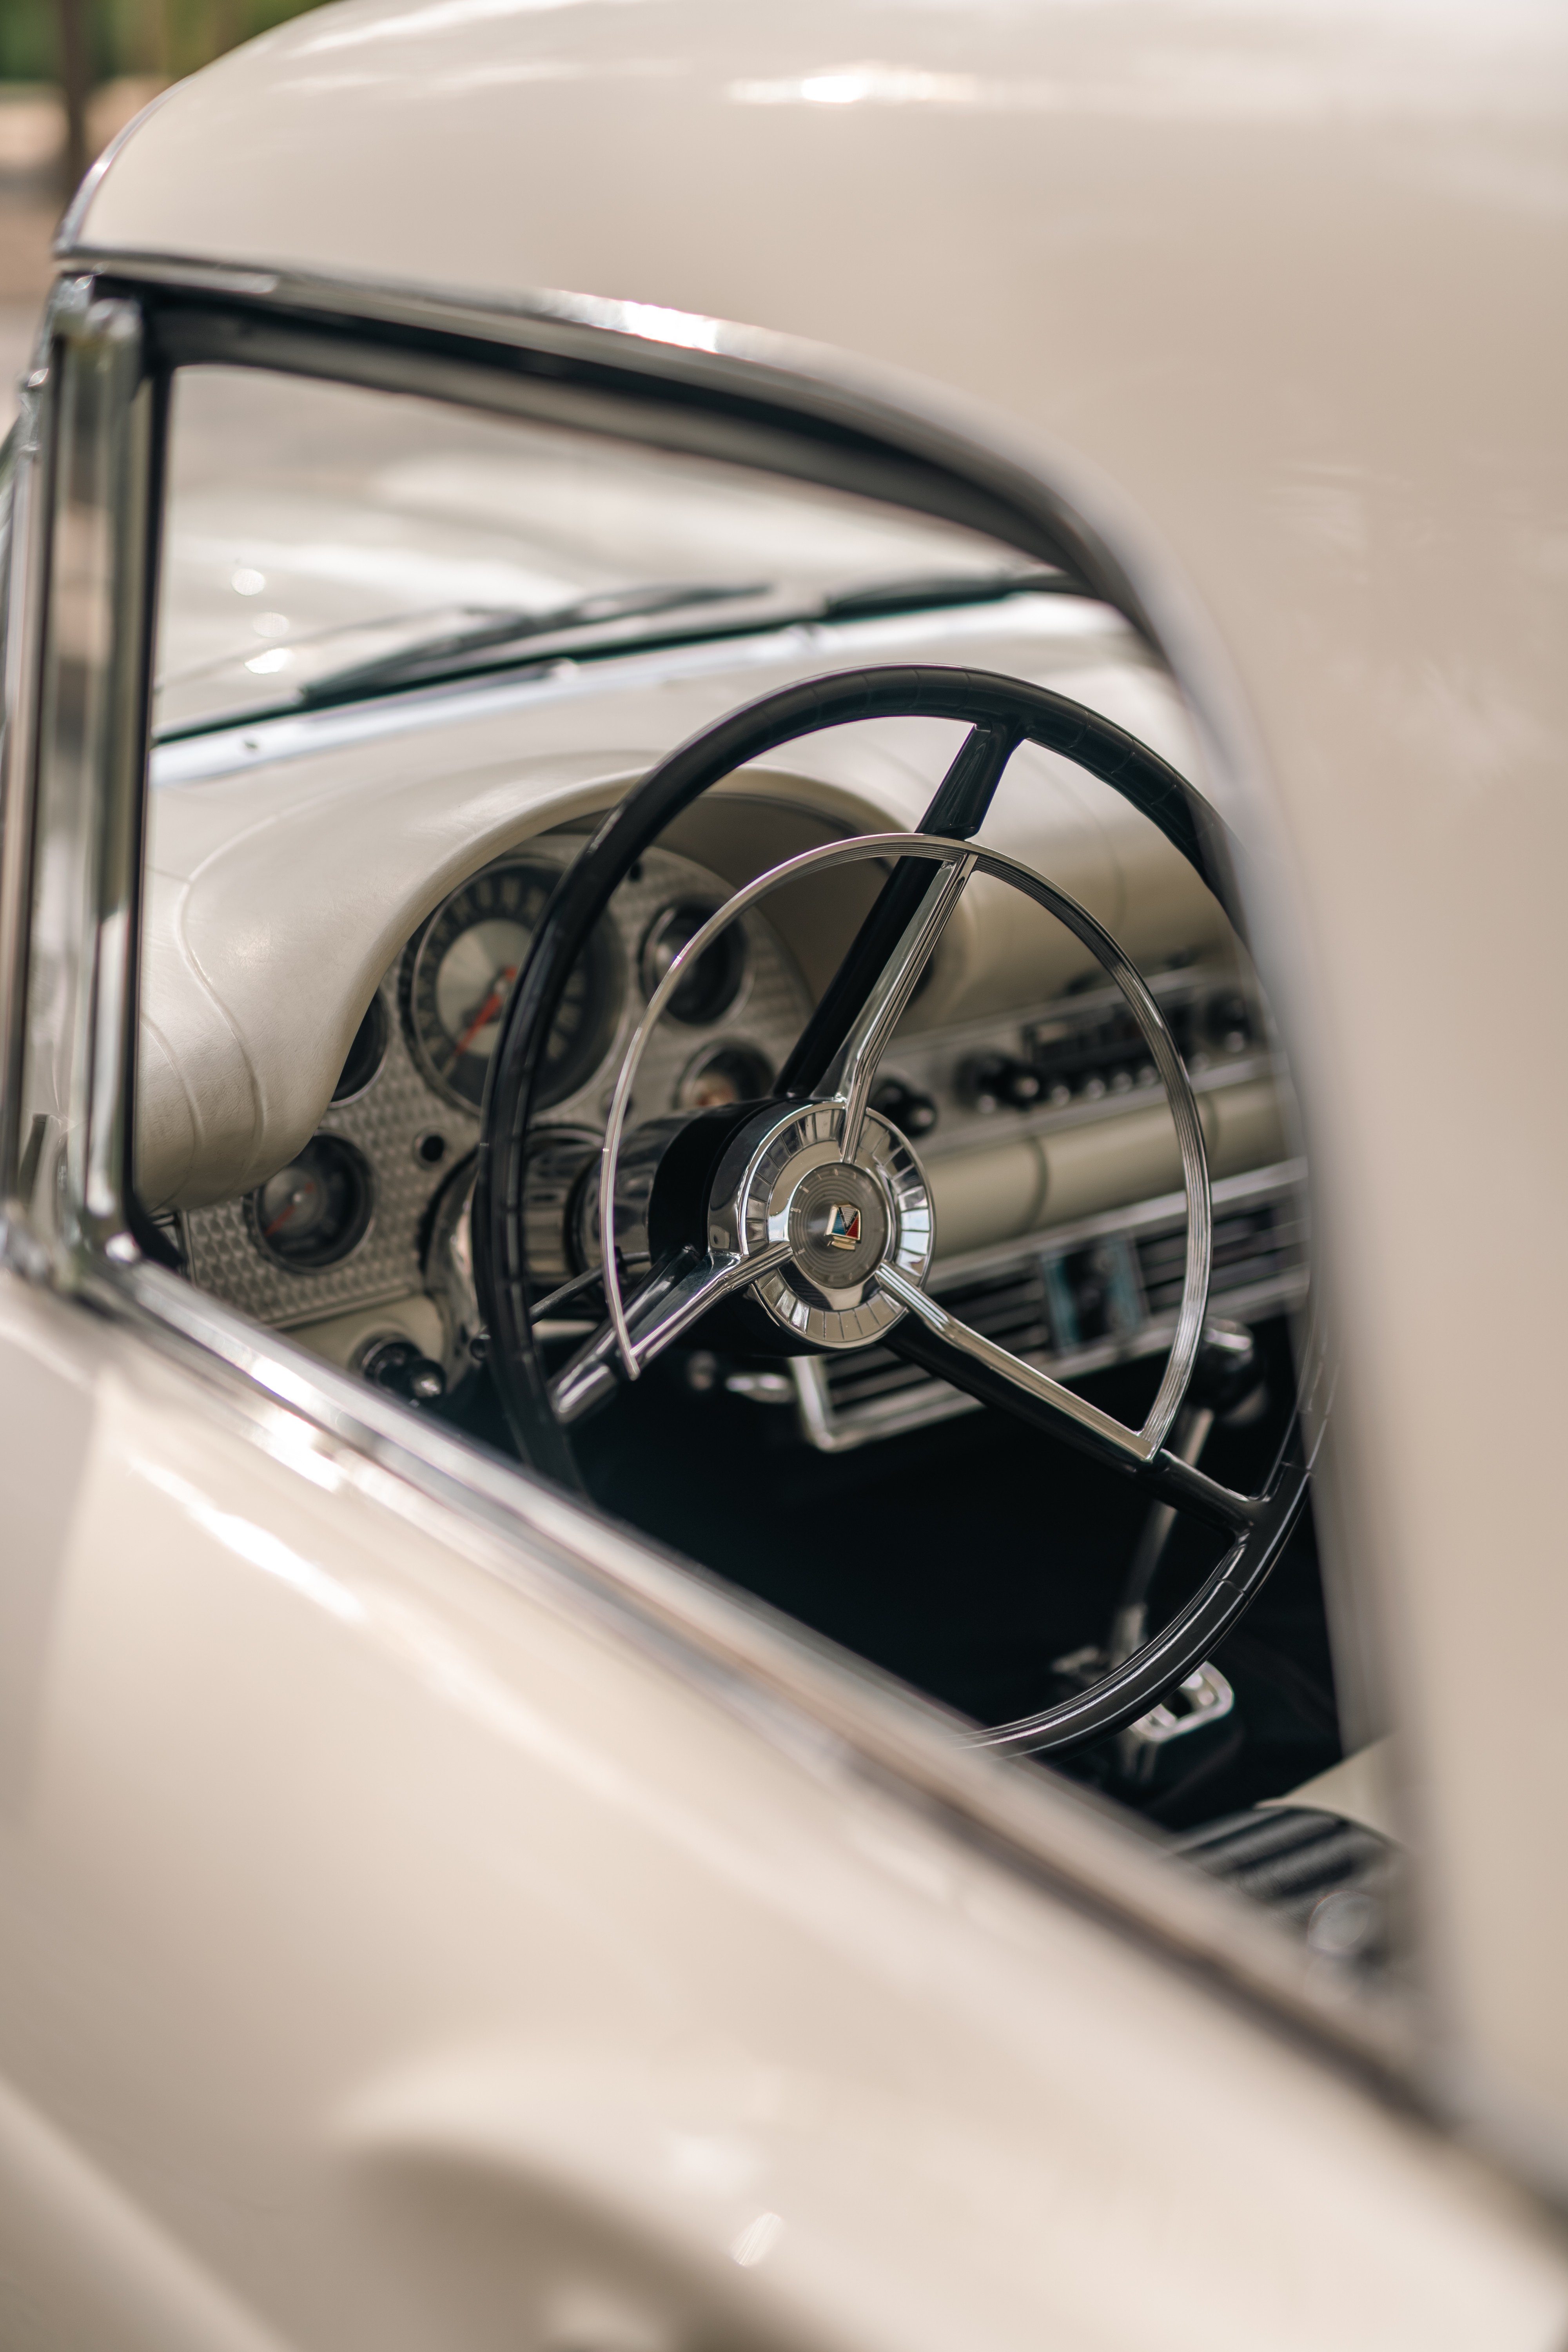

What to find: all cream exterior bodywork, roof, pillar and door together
left=0, top=0, right=1568, bottom=2352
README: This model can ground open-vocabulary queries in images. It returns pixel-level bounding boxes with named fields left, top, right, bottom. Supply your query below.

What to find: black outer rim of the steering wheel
left=472, top=666, right=1309, bottom=1752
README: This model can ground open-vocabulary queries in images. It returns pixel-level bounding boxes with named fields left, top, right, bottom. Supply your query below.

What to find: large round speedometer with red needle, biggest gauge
left=402, top=858, right=621, bottom=1110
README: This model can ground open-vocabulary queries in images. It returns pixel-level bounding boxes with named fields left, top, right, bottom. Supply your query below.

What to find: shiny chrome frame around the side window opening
left=0, top=256, right=1425, bottom=2110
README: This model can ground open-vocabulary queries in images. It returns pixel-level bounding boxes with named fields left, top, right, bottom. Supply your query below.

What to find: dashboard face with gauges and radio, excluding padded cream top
left=162, top=833, right=1305, bottom=1451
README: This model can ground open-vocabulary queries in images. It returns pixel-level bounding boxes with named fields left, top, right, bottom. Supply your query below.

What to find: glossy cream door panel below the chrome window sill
left=0, top=1277, right=1568, bottom=2352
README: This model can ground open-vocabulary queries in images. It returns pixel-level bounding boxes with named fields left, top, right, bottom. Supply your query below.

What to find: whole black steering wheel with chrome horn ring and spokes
left=472, top=666, right=1309, bottom=1755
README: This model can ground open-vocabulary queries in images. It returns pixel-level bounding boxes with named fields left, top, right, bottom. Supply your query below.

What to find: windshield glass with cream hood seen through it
left=155, top=367, right=1049, bottom=736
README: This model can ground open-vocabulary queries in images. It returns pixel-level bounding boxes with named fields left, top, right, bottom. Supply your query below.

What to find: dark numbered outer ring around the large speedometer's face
left=397, top=851, right=625, bottom=1117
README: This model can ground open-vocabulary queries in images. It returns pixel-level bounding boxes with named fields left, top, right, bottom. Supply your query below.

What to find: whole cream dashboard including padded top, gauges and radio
left=139, top=597, right=1305, bottom=1451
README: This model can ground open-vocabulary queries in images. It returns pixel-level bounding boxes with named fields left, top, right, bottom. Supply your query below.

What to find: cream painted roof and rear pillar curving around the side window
left=67, top=0, right=1568, bottom=2180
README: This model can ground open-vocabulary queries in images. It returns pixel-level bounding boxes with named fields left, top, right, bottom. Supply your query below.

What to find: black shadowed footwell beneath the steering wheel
left=451, top=1319, right=1340, bottom=1828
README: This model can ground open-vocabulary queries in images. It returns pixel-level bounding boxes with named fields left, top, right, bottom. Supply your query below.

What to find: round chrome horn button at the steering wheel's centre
left=708, top=1103, right=933, bottom=1348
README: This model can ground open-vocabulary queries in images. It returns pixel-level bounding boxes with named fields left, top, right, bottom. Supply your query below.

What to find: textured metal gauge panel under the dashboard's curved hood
left=176, top=835, right=809, bottom=1362
